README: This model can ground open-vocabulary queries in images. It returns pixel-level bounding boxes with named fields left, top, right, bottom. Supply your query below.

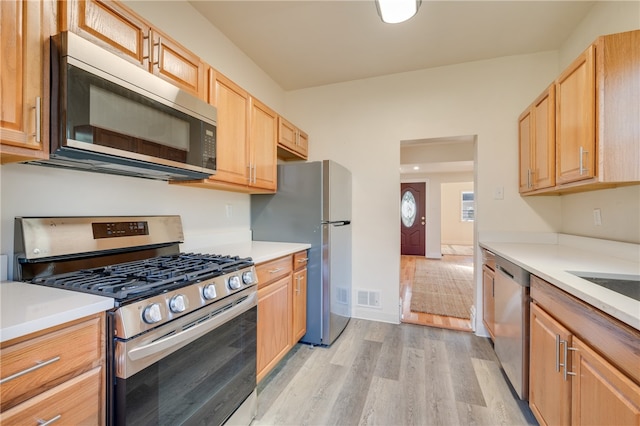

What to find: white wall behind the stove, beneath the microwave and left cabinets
left=0, top=164, right=250, bottom=278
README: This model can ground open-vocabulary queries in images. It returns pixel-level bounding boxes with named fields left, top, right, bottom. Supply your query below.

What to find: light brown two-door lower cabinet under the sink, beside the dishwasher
left=529, top=276, right=640, bottom=425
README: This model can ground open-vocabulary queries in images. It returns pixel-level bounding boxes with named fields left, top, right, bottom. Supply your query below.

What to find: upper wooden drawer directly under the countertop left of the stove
left=0, top=314, right=104, bottom=411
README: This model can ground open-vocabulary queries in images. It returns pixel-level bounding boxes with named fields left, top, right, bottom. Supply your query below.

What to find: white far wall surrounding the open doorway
left=286, top=52, right=560, bottom=322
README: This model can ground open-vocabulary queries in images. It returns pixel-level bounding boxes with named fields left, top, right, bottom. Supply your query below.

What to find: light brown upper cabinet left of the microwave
left=0, top=0, right=56, bottom=163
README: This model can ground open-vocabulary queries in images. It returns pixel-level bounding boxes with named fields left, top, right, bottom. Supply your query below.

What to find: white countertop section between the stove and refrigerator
left=192, top=241, right=311, bottom=263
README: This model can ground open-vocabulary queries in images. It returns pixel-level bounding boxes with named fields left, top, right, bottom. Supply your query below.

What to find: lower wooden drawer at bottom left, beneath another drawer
left=0, top=367, right=104, bottom=426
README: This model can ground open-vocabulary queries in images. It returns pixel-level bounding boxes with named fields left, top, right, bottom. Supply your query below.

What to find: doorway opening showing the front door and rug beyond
left=400, top=136, right=477, bottom=331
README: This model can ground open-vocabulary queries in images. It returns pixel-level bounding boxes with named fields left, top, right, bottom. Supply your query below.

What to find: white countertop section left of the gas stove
left=0, top=281, right=113, bottom=342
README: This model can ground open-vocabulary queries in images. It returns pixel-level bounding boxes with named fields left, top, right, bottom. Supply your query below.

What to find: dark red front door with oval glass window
left=400, top=182, right=426, bottom=256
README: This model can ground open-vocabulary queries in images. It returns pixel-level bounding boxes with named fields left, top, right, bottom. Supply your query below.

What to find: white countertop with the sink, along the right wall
left=480, top=241, right=640, bottom=330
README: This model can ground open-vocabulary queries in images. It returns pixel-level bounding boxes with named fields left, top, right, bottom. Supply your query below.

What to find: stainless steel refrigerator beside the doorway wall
left=251, top=160, right=351, bottom=346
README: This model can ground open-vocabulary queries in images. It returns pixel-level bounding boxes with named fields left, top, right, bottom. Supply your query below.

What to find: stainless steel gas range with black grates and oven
left=15, top=216, right=257, bottom=425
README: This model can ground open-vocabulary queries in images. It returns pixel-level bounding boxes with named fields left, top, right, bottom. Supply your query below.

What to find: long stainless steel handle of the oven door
left=127, top=291, right=258, bottom=361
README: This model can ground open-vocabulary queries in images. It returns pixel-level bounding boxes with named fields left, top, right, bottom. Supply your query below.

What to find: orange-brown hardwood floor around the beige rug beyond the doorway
left=400, top=255, right=473, bottom=331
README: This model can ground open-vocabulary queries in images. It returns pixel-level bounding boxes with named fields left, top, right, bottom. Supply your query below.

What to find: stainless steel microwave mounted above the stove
left=29, top=32, right=217, bottom=180
